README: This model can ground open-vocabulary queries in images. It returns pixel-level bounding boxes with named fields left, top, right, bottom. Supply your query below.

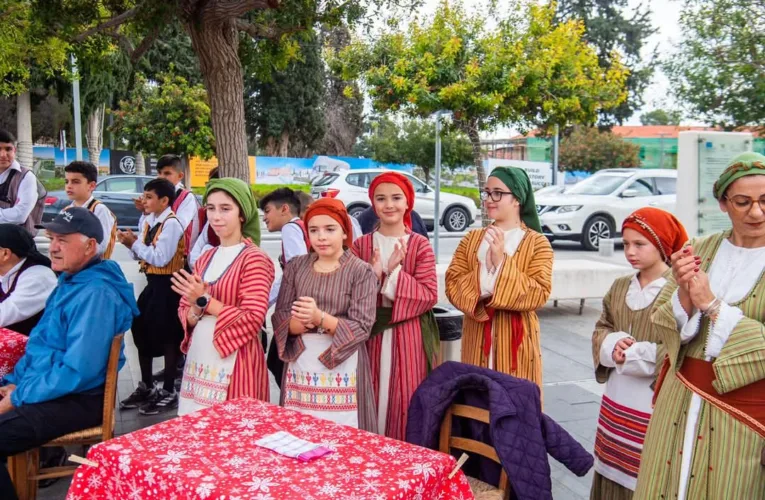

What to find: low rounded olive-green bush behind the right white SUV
left=560, top=127, right=640, bottom=172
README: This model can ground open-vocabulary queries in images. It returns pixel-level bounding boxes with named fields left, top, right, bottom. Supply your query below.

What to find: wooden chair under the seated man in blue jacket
left=8, top=334, right=124, bottom=500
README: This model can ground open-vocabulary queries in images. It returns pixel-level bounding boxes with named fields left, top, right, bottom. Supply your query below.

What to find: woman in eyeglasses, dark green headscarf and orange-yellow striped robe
left=446, top=167, right=553, bottom=388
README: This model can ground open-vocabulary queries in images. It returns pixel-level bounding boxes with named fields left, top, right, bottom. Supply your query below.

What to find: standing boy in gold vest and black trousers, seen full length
left=117, top=179, right=186, bottom=415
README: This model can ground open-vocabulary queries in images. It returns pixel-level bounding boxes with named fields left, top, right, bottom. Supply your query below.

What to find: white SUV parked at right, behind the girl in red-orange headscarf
left=536, top=168, right=677, bottom=250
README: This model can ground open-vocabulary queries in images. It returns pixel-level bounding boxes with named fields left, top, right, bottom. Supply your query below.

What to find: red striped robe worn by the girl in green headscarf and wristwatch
left=178, top=239, right=274, bottom=401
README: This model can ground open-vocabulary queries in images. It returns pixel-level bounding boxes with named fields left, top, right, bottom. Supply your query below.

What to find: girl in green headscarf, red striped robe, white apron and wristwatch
left=173, top=178, right=274, bottom=415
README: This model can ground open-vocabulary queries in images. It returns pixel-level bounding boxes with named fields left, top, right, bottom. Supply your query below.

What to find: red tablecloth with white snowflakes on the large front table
left=67, top=399, right=473, bottom=500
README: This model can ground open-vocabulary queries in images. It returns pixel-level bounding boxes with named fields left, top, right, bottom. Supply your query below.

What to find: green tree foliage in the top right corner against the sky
left=665, top=0, right=765, bottom=128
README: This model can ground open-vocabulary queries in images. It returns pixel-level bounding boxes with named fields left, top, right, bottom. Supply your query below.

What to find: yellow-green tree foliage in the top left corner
left=0, top=0, right=69, bottom=96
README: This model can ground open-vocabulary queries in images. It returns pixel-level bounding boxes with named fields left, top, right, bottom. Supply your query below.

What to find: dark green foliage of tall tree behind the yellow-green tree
left=557, top=0, right=657, bottom=125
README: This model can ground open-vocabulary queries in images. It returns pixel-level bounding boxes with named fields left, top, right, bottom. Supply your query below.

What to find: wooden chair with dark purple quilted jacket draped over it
left=438, top=404, right=510, bottom=500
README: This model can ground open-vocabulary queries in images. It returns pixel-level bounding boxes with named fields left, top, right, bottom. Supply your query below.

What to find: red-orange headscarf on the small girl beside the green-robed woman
left=622, top=207, right=688, bottom=264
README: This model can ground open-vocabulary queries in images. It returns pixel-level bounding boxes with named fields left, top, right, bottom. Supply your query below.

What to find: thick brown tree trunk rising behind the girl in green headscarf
left=186, top=18, right=250, bottom=184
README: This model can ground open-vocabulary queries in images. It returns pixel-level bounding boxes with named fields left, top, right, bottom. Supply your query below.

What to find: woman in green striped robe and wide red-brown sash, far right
left=634, top=153, right=765, bottom=500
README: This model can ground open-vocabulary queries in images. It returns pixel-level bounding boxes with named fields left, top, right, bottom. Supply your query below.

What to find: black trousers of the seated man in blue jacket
left=0, top=389, right=104, bottom=500
